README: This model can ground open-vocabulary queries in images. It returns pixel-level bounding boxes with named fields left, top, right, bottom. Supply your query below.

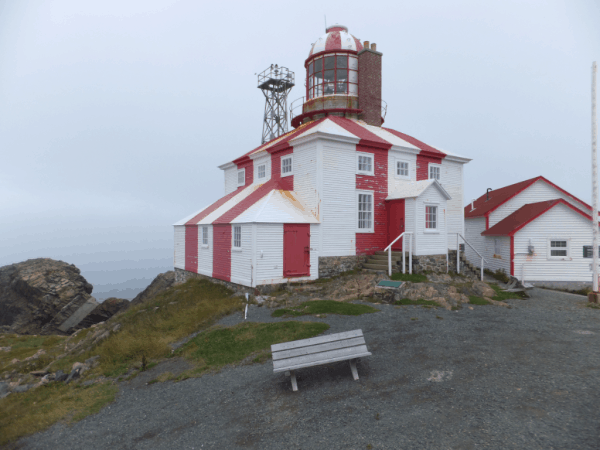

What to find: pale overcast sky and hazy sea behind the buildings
left=0, top=0, right=600, bottom=284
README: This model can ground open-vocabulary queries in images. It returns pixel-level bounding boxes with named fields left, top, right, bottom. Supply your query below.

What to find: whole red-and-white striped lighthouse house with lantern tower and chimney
left=174, top=25, right=470, bottom=287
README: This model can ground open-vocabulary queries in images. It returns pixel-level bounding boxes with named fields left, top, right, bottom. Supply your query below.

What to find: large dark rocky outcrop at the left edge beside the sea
left=0, top=258, right=122, bottom=334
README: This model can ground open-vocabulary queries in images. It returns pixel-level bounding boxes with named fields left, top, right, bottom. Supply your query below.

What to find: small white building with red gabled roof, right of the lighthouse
left=464, top=176, right=592, bottom=287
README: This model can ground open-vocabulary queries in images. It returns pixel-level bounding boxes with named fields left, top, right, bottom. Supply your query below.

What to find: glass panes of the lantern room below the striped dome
left=306, top=53, right=358, bottom=99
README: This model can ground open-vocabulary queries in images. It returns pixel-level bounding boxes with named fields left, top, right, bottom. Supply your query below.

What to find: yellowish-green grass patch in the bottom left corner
left=0, top=383, right=119, bottom=445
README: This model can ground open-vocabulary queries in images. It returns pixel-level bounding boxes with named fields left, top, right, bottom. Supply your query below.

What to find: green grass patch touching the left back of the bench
left=176, top=321, right=329, bottom=374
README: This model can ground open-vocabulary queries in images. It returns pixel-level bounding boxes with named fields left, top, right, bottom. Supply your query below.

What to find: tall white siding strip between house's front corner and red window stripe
left=320, top=142, right=357, bottom=256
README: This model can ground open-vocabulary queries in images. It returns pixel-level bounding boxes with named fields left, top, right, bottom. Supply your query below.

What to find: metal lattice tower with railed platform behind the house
left=258, top=64, right=294, bottom=144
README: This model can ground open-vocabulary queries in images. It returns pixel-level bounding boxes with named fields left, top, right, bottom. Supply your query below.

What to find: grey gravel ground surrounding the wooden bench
left=12, top=288, right=600, bottom=450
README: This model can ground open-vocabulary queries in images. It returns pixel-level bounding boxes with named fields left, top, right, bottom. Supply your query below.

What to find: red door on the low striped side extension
left=283, top=223, right=310, bottom=277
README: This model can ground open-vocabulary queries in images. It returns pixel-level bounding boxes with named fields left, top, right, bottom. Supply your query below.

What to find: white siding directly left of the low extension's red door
left=254, top=223, right=283, bottom=285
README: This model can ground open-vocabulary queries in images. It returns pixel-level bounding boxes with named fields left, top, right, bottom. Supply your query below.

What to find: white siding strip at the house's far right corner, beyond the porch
left=440, top=159, right=465, bottom=250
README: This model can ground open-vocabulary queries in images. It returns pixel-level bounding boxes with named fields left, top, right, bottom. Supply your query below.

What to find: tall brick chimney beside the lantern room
left=358, top=41, right=383, bottom=127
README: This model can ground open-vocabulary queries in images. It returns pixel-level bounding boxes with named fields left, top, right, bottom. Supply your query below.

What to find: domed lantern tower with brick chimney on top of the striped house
left=291, top=25, right=385, bottom=128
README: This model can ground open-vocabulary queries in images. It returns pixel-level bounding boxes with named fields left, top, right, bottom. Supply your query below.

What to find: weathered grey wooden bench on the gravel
left=271, top=330, right=371, bottom=391
